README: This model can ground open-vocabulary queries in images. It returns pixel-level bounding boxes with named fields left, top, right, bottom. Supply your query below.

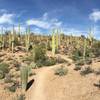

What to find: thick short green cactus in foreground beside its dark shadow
left=21, top=66, right=28, bottom=91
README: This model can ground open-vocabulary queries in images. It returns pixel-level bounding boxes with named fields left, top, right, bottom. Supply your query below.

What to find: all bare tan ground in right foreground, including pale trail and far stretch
left=26, top=54, right=100, bottom=100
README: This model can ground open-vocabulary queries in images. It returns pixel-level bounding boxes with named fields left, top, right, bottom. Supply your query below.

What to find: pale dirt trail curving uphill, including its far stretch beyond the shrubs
left=27, top=55, right=72, bottom=100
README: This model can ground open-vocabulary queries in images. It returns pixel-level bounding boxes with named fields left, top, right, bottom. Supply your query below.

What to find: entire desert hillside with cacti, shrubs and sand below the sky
left=0, top=25, right=100, bottom=100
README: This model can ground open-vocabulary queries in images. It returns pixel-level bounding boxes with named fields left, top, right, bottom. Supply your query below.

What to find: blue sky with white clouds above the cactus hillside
left=0, top=0, right=100, bottom=39
